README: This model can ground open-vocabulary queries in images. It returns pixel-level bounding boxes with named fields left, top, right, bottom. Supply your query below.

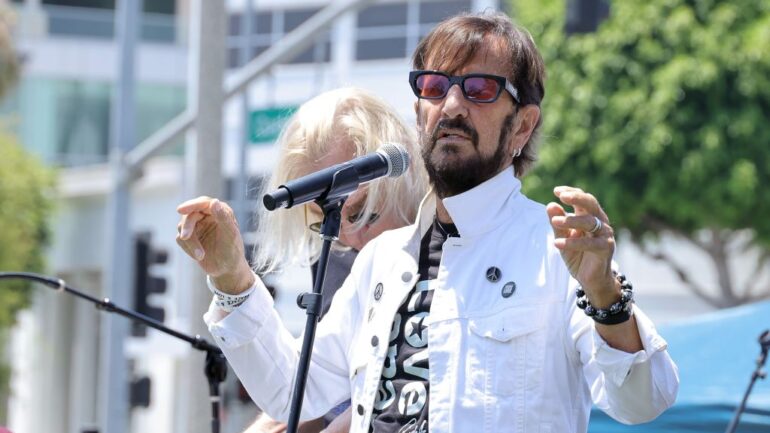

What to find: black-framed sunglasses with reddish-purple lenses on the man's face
left=409, top=71, right=520, bottom=104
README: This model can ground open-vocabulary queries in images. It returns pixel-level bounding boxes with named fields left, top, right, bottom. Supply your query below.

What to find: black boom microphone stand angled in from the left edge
left=0, top=272, right=227, bottom=433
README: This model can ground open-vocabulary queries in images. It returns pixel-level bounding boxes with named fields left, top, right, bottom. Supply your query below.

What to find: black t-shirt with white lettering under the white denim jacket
left=369, top=219, right=456, bottom=433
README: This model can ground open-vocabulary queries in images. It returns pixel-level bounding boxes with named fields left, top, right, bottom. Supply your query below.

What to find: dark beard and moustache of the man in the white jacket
left=420, top=112, right=516, bottom=198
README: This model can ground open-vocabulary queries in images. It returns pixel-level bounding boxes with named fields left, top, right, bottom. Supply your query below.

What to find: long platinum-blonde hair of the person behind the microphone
left=253, top=88, right=428, bottom=273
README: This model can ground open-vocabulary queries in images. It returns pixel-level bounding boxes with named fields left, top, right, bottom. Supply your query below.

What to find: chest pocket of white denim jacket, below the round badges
left=468, top=305, right=546, bottom=396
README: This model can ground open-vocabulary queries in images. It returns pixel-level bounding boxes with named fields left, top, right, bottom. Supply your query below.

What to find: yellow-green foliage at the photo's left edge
left=0, top=132, right=53, bottom=328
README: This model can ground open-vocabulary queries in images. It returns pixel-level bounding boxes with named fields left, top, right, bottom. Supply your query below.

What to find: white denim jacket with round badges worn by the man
left=204, top=170, right=679, bottom=433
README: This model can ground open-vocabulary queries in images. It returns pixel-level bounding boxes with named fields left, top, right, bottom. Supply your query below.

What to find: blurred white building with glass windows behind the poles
left=1, top=0, right=720, bottom=433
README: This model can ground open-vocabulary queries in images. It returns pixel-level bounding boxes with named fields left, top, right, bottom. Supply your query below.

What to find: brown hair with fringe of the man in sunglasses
left=412, top=12, right=545, bottom=177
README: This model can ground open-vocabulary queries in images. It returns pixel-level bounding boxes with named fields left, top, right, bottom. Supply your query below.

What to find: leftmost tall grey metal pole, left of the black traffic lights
left=99, top=0, right=142, bottom=433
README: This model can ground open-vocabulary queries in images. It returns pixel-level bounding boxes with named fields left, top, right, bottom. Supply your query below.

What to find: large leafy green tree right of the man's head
left=511, top=0, right=770, bottom=307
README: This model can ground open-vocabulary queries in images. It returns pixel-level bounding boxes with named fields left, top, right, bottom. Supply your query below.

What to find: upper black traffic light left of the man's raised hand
left=131, top=233, right=168, bottom=337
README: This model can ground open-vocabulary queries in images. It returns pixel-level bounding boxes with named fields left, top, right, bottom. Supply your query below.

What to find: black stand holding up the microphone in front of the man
left=287, top=196, right=347, bottom=433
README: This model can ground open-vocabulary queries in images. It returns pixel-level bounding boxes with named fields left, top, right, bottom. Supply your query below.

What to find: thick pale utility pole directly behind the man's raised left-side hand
left=174, top=0, right=225, bottom=433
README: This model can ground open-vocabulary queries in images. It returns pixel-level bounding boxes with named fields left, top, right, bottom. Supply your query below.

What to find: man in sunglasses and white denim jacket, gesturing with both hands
left=201, top=13, right=678, bottom=433
